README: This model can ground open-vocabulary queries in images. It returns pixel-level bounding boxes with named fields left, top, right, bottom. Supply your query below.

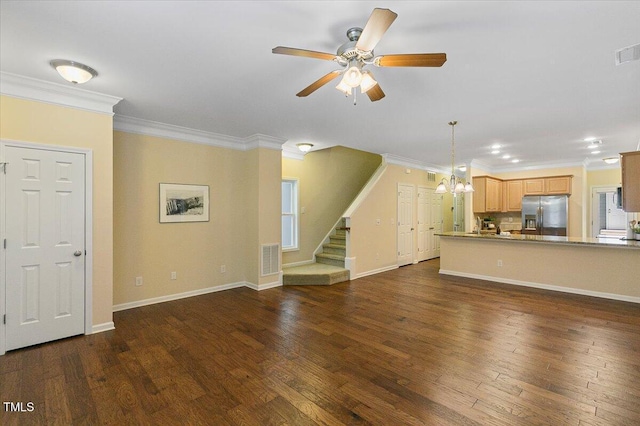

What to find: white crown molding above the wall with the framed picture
left=113, top=114, right=286, bottom=151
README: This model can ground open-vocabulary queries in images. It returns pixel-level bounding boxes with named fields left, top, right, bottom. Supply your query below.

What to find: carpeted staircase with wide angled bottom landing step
left=282, top=219, right=350, bottom=285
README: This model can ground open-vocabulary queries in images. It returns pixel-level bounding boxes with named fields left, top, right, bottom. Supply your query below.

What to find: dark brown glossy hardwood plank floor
left=0, top=260, right=640, bottom=426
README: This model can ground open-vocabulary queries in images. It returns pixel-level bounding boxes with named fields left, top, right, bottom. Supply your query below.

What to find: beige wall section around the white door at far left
left=0, top=96, right=113, bottom=325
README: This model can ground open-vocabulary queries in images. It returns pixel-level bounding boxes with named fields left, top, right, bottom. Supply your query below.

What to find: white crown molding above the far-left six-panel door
left=0, top=72, right=122, bottom=116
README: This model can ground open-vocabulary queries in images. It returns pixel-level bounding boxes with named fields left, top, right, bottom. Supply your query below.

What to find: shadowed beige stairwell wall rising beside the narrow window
left=282, top=146, right=382, bottom=265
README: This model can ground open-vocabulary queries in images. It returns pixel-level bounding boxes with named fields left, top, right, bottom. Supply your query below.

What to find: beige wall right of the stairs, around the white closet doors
left=350, top=164, right=453, bottom=276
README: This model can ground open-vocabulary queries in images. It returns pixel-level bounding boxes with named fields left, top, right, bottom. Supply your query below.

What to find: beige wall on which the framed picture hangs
left=114, top=132, right=280, bottom=305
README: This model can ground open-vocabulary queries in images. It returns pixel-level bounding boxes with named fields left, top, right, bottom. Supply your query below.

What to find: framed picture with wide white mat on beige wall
left=160, top=183, right=209, bottom=223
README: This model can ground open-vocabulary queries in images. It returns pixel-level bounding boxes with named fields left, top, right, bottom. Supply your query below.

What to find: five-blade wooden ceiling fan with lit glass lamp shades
left=272, top=8, right=447, bottom=103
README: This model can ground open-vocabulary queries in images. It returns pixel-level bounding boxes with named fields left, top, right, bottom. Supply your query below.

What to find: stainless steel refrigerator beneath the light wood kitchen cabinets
left=522, top=195, right=569, bottom=236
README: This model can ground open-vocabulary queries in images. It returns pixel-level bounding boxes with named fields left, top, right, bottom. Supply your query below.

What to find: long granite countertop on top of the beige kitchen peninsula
left=436, top=232, right=640, bottom=249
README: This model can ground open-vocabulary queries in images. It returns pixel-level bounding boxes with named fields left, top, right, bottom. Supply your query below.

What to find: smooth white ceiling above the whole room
left=0, top=0, right=640, bottom=171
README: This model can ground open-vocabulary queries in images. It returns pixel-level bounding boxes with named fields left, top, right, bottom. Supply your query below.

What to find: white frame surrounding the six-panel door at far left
left=0, top=139, right=93, bottom=355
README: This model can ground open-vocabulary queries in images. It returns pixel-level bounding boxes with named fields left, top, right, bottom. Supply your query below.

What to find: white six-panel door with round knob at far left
left=4, top=146, right=86, bottom=350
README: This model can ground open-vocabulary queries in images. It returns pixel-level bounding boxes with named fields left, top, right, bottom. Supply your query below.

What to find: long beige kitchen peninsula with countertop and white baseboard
left=438, top=232, right=640, bottom=303
